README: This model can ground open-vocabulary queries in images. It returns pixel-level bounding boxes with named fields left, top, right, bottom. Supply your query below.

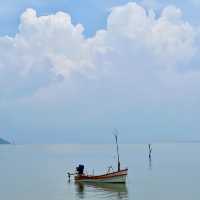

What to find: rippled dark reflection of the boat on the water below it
left=76, top=182, right=128, bottom=199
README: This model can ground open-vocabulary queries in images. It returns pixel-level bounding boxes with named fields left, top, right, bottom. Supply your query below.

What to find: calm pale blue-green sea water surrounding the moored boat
left=0, top=144, right=200, bottom=200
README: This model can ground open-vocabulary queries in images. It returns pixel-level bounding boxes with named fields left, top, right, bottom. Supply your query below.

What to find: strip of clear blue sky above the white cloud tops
left=0, top=0, right=200, bottom=36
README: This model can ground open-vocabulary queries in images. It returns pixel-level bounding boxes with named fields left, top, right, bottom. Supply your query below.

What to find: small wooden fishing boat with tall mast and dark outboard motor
left=68, top=134, right=128, bottom=183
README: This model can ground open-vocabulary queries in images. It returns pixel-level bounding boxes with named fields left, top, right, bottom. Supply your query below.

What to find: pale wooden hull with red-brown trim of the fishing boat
left=75, top=169, right=128, bottom=183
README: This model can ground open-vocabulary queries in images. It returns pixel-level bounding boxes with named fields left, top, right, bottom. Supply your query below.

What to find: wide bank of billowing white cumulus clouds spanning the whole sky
left=0, top=3, right=200, bottom=100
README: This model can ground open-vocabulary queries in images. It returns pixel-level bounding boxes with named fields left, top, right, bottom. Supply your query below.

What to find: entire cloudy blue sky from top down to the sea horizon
left=0, top=0, right=200, bottom=144
